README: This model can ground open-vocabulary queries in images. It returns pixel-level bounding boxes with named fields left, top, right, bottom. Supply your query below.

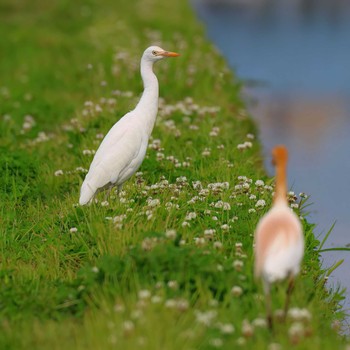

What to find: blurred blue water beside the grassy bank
left=192, top=0, right=350, bottom=320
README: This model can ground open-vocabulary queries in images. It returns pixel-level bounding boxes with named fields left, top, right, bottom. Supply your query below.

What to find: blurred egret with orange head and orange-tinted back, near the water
left=254, top=146, right=304, bottom=328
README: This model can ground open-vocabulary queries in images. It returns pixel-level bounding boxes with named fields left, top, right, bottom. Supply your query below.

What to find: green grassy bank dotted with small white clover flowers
left=0, top=0, right=346, bottom=349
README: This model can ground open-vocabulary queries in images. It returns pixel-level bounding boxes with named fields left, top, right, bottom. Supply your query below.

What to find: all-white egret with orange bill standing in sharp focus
left=79, top=46, right=179, bottom=205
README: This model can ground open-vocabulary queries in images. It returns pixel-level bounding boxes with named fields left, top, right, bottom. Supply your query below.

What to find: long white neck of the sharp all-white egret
left=135, top=59, right=159, bottom=135
